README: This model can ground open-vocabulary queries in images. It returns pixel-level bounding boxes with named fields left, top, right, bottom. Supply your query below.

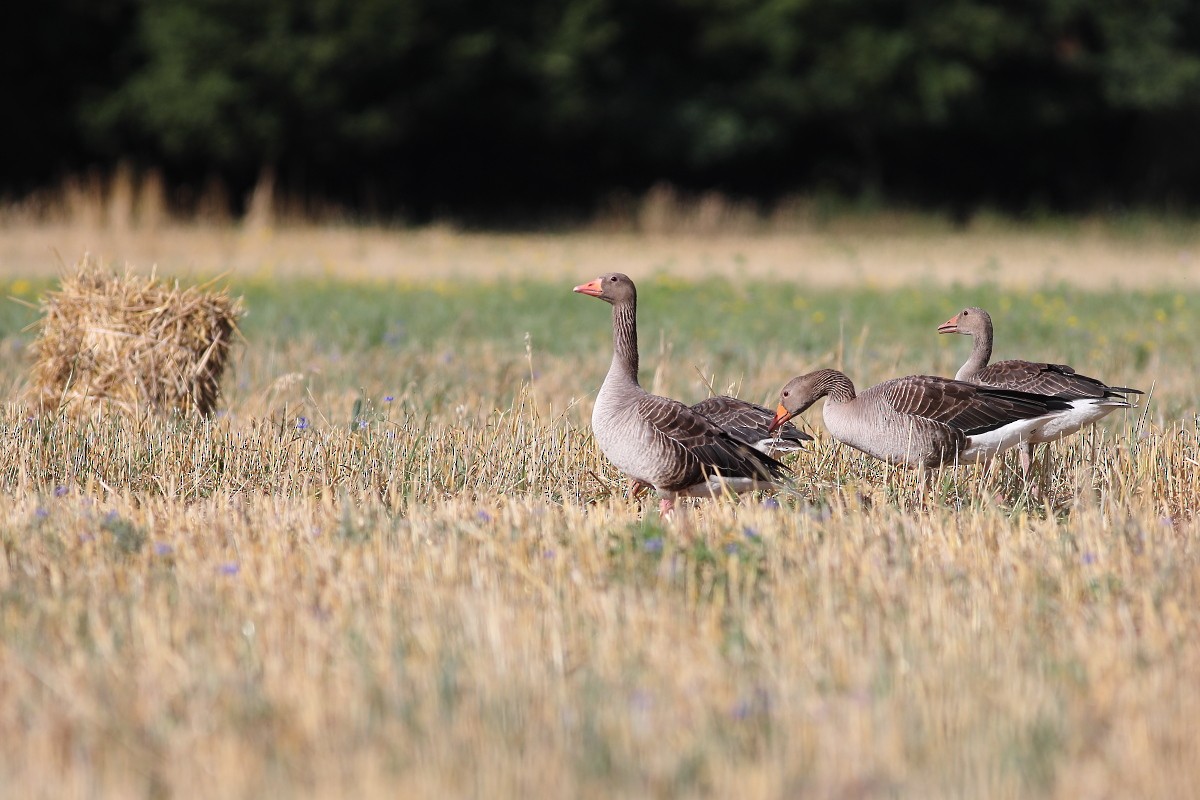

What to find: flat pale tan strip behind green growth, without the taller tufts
left=0, top=219, right=1200, bottom=289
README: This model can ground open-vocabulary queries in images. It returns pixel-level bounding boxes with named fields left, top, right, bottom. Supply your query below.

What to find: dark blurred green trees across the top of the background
left=0, top=0, right=1200, bottom=218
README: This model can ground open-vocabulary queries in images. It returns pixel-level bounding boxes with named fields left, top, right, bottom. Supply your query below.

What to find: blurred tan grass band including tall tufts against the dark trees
left=0, top=166, right=1200, bottom=289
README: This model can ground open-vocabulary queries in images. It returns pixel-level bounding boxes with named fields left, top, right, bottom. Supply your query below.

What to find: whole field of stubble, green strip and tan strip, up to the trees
left=0, top=229, right=1200, bottom=798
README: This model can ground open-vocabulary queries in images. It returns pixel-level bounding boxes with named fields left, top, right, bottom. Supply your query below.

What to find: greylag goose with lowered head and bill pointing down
left=772, top=369, right=1067, bottom=468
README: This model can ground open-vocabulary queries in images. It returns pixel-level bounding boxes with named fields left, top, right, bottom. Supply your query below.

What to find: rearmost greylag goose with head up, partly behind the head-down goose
left=937, top=306, right=1141, bottom=474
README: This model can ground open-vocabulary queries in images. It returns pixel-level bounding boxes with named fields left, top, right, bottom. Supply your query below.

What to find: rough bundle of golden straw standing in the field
left=32, top=255, right=242, bottom=415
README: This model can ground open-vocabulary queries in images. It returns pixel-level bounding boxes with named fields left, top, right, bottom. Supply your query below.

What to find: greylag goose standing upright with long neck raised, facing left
left=575, top=272, right=788, bottom=513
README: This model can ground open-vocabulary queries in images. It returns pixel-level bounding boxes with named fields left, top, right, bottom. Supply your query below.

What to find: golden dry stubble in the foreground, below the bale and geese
left=0, top=399, right=1200, bottom=798
